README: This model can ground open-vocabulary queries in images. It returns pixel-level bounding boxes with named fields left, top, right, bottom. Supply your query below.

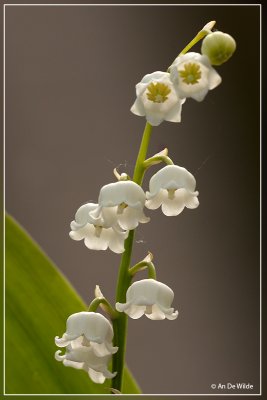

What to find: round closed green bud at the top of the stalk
left=201, top=31, right=236, bottom=65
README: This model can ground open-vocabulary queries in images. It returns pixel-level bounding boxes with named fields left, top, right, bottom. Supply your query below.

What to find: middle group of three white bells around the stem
left=70, top=165, right=199, bottom=253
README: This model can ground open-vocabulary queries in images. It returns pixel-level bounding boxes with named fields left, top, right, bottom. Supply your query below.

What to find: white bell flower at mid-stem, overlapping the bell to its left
left=90, top=181, right=150, bottom=230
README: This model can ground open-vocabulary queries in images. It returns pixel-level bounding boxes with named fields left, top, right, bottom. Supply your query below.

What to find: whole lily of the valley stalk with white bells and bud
left=55, top=21, right=236, bottom=393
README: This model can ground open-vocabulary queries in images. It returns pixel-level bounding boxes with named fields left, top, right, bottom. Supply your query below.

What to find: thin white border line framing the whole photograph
left=3, top=3, right=262, bottom=397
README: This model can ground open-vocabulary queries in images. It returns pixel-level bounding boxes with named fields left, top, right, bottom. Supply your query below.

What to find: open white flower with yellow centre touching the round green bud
left=169, top=52, right=222, bottom=101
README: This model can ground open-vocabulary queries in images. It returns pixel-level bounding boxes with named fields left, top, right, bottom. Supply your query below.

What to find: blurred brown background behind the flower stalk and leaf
left=6, top=5, right=260, bottom=394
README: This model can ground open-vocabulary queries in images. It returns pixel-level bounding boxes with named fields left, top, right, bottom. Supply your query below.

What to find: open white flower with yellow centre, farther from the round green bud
left=131, top=71, right=185, bottom=126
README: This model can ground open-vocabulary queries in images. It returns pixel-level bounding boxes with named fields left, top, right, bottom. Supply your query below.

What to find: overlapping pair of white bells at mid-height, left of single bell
left=70, top=180, right=149, bottom=253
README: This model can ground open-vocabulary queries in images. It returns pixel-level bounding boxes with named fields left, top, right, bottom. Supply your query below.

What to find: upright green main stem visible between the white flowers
left=112, top=122, right=152, bottom=392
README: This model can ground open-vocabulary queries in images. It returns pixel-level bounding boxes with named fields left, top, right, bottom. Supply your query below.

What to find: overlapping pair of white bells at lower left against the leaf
left=55, top=312, right=118, bottom=383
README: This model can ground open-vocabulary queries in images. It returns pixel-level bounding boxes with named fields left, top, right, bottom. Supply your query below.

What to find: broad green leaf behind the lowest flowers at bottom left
left=5, top=216, right=140, bottom=394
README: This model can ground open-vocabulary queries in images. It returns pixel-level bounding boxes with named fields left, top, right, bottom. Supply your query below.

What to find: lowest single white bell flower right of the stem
left=116, top=279, right=178, bottom=320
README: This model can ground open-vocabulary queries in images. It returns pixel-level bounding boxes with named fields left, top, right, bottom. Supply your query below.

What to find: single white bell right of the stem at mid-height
left=146, top=165, right=199, bottom=216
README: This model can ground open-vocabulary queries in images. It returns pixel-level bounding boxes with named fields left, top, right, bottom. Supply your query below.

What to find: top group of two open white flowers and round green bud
left=131, top=24, right=236, bottom=126
